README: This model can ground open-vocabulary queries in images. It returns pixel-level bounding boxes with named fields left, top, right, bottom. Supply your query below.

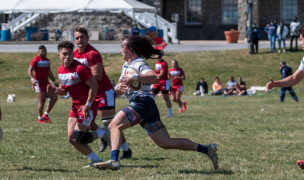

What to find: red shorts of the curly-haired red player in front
left=69, top=103, right=97, bottom=126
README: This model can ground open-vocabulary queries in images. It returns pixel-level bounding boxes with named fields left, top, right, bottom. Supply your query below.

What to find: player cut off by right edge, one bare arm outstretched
left=265, top=25, right=304, bottom=169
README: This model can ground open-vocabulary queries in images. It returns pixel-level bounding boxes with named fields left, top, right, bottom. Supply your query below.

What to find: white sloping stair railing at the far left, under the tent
left=1, top=13, right=40, bottom=34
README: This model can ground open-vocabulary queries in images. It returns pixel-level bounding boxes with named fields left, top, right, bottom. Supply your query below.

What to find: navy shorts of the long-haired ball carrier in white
left=121, top=94, right=165, bottom=135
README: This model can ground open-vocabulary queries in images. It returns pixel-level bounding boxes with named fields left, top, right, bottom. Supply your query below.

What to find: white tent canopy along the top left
left=0, top=0, right=155, bottom=13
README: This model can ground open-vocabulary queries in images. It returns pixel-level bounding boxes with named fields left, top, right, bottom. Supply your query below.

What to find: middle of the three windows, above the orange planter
left=222, top=0, right=238, bottom=24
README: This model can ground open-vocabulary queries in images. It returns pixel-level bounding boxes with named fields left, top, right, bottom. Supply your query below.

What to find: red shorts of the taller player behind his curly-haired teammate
left=95, top=87, right=116, bottom=111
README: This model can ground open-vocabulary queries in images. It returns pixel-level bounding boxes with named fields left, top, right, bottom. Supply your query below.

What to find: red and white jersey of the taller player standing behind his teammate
left=74, top=44, right=112, bottom=95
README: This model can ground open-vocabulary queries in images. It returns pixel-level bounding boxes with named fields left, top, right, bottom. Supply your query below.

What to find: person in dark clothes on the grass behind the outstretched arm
left=280, top=61, right=298, bottom=102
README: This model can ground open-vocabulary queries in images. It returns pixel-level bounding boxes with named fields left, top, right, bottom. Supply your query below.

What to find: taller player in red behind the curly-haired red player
left=74, top=27, right=132, bottom=159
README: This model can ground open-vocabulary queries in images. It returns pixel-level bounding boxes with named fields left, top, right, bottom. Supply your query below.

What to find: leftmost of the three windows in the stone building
left=185, top=0, right=202, bottom=25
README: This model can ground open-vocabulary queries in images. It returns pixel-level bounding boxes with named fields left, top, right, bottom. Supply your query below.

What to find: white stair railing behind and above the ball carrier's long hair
left=124, top=11, right=179, bottom=43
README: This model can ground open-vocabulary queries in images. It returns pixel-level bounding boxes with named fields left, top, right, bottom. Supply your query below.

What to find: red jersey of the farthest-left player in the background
left=30, top=55, right=51, bottom=80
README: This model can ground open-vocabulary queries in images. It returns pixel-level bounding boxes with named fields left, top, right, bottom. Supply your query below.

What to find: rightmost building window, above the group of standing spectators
left=281, top=0, right=298, bottom=23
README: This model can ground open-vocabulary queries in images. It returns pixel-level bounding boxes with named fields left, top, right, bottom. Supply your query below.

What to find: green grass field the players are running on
left=0, top=47, right=304, bottom=179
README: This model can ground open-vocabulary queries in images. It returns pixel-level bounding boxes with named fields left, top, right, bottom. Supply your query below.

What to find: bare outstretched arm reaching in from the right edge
left=265, top=69, right=304, bottom=92
